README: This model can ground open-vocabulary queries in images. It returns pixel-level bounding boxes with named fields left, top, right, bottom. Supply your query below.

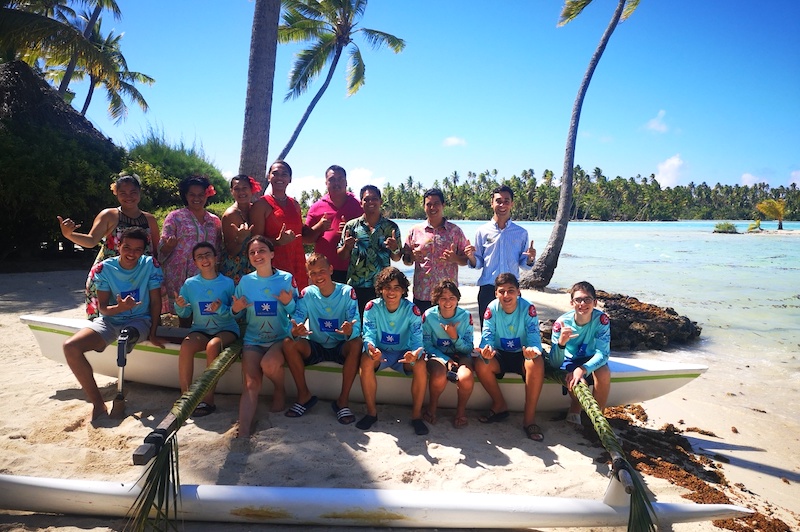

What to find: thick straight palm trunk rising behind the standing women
left=239, top=0, right=281, bottom=187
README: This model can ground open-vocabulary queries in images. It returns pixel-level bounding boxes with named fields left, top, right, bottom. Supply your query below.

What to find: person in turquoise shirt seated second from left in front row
left=174, top=242, right=239, bottom=417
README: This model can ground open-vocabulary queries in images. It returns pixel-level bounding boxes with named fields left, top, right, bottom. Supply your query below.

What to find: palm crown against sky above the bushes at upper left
left=74, top=19, right=155, bottom=124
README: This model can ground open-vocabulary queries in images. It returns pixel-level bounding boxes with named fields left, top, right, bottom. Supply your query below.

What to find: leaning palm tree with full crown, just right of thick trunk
left=278, top=0, right=406, bottom=159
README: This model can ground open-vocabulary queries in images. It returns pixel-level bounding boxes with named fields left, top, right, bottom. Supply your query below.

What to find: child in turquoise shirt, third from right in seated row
left=422, top=279, right=475, bottom=429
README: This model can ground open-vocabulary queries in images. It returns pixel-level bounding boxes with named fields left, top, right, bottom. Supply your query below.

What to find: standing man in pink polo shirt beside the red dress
left=304, top=164, right=364, bottom=283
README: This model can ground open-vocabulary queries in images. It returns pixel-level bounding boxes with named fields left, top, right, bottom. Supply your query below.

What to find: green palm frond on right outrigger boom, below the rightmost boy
left=546, top=369, right=657, bottom=532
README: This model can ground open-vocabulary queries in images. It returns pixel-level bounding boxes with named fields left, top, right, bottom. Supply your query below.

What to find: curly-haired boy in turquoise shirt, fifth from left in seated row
left=356, top=266, right=428, bottom=436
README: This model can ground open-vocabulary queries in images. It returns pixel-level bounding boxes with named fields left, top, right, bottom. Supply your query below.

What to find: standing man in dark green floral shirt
left=336, top=185, right=402, bottom=315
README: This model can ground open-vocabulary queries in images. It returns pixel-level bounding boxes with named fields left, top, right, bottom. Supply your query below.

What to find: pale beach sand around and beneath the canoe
left=0, top=270, right=800, bottom=532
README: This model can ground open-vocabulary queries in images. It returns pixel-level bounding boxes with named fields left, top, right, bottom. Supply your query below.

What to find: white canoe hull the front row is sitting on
left=20, top=315, right=708, bottom=412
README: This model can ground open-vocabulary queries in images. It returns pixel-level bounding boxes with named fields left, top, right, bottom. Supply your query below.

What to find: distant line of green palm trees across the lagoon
left=300, top=166, right=800, bottom=221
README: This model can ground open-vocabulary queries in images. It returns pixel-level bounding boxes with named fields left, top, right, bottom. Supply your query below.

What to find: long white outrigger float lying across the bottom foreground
left=0, top=475, right=752, bottom=529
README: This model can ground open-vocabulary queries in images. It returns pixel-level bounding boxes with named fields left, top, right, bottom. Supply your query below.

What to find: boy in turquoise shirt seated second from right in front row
left=475, top=273, right=544, bottom=441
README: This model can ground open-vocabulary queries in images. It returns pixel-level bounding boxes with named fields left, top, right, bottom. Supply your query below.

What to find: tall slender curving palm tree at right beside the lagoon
left=523, top=0, right=639, bottom=288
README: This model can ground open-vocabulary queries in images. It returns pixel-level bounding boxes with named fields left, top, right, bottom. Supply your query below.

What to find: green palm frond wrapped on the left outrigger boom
left=125, top=340, right=242, bottom=532
